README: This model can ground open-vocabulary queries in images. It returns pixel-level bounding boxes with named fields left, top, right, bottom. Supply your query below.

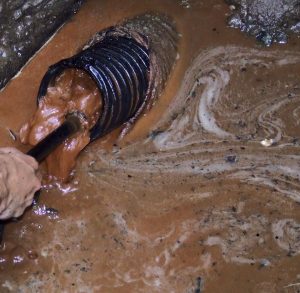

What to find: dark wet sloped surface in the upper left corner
left=0, top=0, right=83, bottom=89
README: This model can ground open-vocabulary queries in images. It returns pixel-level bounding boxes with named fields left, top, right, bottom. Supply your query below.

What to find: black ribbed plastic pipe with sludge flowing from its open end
left=38, top=36, right=150, bottom=140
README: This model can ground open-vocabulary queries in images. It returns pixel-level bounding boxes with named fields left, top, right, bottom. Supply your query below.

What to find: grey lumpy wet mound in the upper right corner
left=226, top=0, right=300, bottom=46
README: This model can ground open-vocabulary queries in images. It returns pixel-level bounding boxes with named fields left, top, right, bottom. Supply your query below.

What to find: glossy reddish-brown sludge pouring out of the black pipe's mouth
left=20, top=69, right=102, bottom=181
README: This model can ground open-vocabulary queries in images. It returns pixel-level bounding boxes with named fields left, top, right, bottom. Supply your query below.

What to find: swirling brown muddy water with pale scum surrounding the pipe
left=0, top=0, right=300, bottom=292
